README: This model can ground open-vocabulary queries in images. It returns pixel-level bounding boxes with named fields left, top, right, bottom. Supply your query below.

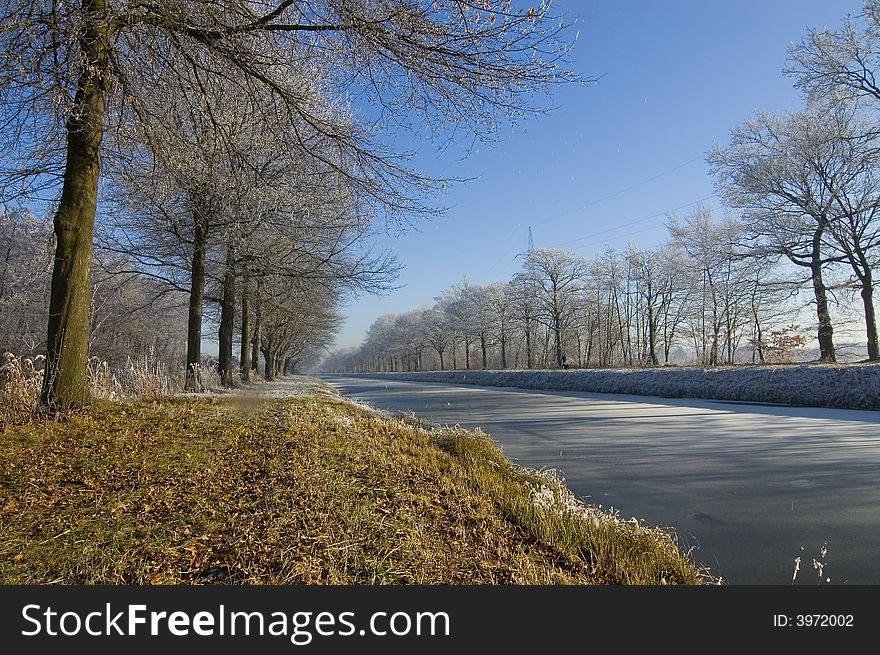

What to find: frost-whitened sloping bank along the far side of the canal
left=332, top=364, right=880, bottom=409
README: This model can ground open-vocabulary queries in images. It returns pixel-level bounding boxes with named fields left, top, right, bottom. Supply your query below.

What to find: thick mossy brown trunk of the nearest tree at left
left=40, top=0, right=110, bottom=409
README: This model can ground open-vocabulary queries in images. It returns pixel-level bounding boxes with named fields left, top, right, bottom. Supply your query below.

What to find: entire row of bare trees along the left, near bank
left=0, top=0, right=570, bottom=408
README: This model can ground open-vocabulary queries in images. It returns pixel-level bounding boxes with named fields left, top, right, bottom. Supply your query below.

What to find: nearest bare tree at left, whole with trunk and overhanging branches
left=0, top=0, right=580, bottom=407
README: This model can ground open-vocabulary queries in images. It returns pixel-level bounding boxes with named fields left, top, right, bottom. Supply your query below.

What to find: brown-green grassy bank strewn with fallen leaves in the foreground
left=0, top=395, right=708, bottom=584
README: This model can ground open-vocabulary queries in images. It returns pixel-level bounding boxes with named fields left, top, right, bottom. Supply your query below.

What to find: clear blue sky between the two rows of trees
left=336, top=0, right=861, bottom=347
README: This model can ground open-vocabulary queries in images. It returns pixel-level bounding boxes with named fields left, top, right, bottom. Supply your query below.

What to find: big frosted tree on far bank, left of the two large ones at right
left=709, top=105, right=864, bottom=362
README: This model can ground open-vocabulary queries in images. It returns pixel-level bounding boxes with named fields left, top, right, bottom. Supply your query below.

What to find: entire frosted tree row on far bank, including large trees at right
left=326, top=0, right=880, bottom=371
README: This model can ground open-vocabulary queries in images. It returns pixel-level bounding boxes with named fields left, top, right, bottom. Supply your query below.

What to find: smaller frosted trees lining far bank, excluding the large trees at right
left=322, top=207, right=797, bottom=372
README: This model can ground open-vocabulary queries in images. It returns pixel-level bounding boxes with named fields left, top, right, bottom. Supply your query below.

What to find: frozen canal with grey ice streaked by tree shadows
left=326, top=377, right=880, bottom=585
